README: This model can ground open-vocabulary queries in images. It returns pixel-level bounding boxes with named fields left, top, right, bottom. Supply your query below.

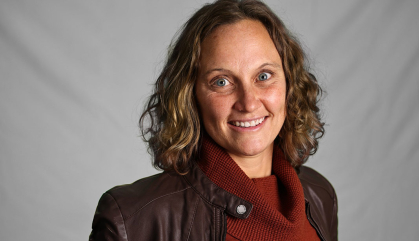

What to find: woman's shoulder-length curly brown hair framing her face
left=139, top=0, right=324, bottom=174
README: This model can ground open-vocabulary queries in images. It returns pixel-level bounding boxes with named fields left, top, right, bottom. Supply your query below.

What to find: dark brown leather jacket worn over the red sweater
left=89, top=165, right=337, bottom=241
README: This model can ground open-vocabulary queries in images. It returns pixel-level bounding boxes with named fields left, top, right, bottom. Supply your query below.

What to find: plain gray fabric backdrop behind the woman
left=0, top=0, right=419, bottom=240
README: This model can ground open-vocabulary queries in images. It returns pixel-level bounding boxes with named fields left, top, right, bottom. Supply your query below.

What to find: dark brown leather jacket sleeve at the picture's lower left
left=89, top=193, right=128, bottom=241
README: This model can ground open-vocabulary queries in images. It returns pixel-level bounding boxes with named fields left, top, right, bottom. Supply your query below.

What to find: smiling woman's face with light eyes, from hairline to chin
left=195, top=20, right=286, bottom=159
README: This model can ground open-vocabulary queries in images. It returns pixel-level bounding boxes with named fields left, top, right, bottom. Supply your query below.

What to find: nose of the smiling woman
left=234, top=85, right=262, bottom=112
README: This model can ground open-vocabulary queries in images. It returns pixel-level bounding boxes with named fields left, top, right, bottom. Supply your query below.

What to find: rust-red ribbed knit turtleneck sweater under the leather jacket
left=198, top=137, right=319, bottom=241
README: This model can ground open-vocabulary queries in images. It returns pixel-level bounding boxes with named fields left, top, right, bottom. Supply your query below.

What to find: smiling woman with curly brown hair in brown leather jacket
left=90, top=0, right=337, bottom=240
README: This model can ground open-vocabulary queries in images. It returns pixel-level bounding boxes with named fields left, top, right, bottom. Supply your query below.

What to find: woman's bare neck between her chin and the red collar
left=228, top=144, right=273, bottom=179
